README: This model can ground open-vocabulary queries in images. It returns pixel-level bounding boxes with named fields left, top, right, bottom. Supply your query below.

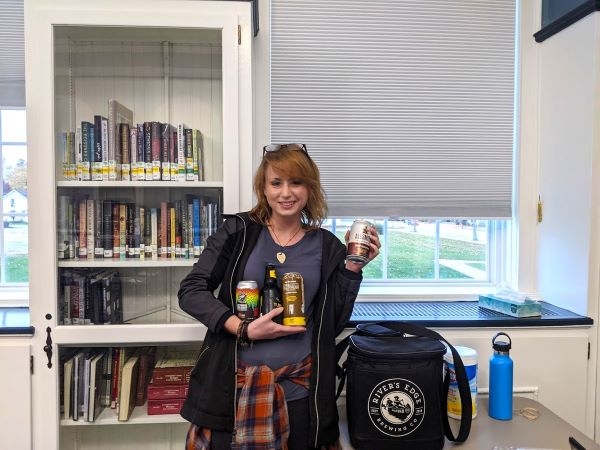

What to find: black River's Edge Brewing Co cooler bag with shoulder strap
left=337, top=322, right=472, bottom=450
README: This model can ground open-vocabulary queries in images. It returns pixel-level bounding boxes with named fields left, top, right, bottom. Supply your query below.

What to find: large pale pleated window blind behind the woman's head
left=270, top=0, right=516, bottom=218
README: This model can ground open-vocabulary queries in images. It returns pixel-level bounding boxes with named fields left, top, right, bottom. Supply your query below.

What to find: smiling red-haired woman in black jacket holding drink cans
left=178, top=144, right=380, bottom=450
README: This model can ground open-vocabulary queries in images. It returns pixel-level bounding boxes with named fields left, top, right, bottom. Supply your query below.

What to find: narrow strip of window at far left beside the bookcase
left=0, top=108, right=29, bottom=290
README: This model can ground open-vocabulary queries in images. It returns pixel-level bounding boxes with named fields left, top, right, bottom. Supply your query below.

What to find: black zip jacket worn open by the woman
left=178, top=213, right=362, bottom=447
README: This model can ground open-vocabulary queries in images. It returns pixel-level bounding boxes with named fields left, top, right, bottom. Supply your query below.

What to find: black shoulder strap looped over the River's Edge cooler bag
left=335, top=321, right=473, bottom=442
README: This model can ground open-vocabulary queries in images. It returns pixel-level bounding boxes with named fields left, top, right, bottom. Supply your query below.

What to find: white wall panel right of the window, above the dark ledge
left=538, top=14, right=598, bottom=314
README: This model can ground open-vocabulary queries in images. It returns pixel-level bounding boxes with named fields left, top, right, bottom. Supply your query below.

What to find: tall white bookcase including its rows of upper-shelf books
left=25, top=0, right=253, bottom=449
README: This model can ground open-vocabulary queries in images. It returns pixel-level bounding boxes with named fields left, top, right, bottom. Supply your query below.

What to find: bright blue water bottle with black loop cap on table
left=489, top=333, right=513, bottom=420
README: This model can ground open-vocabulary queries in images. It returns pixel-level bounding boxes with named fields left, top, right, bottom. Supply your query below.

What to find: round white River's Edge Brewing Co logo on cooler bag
left=368, top=378, right=425, bottom=437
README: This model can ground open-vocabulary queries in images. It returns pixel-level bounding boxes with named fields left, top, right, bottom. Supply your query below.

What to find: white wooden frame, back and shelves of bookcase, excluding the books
left=25, top=0, right=253, bottom=449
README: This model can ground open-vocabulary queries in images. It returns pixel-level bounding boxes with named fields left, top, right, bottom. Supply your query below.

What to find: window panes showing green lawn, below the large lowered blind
left=325, top=218, right=507, bottom=286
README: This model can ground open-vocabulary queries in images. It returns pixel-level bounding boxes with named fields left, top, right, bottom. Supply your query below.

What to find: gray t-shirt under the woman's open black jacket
left=238, top=227, right=323, bottom=400
